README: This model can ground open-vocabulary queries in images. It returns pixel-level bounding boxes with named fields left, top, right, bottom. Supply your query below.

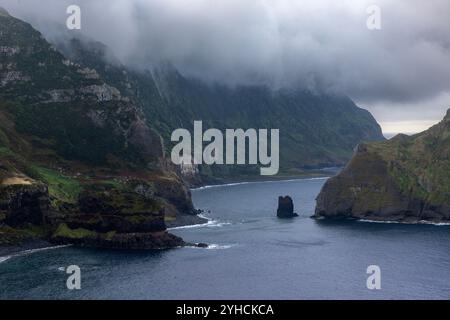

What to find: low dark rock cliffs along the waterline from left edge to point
left=0, top=170, right=192, bottom=249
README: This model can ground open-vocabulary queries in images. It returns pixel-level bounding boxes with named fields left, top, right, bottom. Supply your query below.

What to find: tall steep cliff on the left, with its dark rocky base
left=0, top=6, right=194, bottom=249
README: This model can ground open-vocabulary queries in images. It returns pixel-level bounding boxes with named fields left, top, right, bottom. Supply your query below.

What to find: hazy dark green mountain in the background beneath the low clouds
left=57, top=39, right=384, bottom=182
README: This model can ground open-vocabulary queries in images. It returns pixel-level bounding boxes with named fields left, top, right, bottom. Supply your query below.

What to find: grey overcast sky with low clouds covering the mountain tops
left=0, top=0, right=450, bottom=132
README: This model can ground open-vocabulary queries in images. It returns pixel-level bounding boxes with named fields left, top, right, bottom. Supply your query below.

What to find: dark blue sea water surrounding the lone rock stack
left=0, top=179, right=450, bottom=299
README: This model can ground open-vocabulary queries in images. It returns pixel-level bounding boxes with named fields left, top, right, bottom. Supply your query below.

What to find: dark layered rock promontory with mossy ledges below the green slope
left=47, top=180, right=188, bottom=249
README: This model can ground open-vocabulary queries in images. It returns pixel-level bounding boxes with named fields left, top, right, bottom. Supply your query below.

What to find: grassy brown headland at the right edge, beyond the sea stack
left=315, top=110, right=450, bottom=222
